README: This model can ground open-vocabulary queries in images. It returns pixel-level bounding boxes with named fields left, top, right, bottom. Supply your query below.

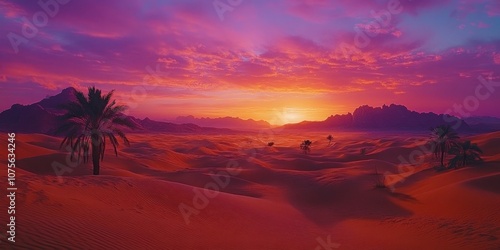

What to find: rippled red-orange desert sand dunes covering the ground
left=0, top=132, right=500, bottom=249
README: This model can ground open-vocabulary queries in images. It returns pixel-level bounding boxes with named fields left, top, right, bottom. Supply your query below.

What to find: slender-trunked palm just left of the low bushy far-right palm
left=430, top=125, right=460, bottom=167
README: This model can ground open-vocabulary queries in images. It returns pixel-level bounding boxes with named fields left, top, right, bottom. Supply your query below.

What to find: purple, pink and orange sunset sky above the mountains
left=0, top=0, right=500, bottom=124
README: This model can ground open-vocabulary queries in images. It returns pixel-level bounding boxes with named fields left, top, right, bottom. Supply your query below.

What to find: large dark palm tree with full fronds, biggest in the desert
left=57, top=87, right=138, bottom=175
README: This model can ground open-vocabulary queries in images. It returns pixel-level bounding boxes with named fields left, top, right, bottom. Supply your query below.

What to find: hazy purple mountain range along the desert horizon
left=0, top=88, right=500, bottom=134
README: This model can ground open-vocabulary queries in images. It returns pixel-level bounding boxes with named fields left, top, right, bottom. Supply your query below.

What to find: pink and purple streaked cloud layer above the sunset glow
left=0, top=0, right=500, bottom=118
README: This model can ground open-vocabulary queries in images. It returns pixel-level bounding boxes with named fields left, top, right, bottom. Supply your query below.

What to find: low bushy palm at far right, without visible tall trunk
left=449, top=141, right=483, bottom=168
